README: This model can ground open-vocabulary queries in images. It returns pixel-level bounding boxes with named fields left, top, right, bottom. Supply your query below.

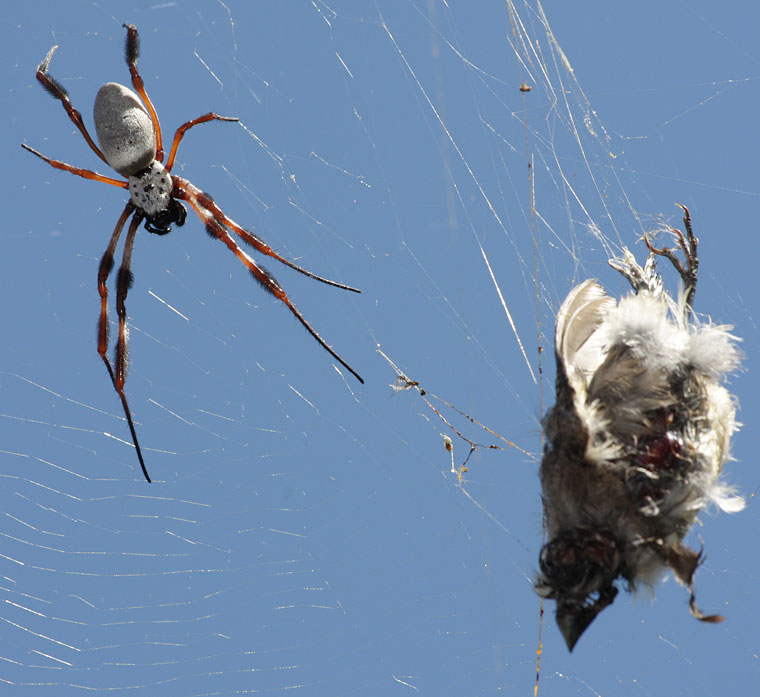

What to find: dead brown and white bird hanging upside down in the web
left=536, top=206, right=744, bottom=651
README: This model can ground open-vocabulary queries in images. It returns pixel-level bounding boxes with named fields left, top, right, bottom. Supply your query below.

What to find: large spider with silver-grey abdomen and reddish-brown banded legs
left=21, top=24, right=364, bottom=482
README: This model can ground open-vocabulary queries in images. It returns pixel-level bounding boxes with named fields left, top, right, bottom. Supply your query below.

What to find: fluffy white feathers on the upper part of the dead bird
left=555, top=264, right=744, bottom=513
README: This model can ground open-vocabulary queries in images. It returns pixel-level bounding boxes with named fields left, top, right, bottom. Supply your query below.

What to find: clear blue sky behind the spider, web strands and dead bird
left=5, top=0, right=760, bottom=695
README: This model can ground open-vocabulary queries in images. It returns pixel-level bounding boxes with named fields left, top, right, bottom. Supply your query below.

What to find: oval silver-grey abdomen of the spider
left=93, top=82, right=156, bottom=177
